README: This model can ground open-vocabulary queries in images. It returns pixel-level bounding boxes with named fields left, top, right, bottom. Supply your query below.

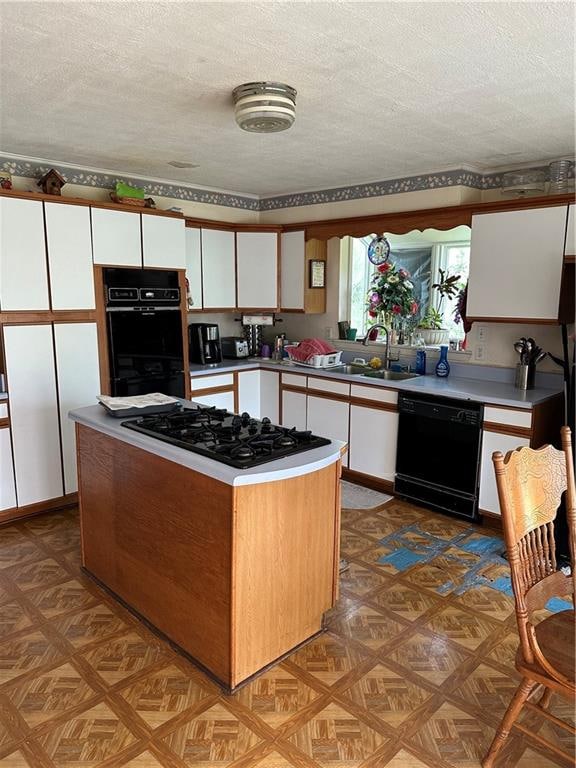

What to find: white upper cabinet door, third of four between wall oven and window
left=236, top=232, right=278, bottom=309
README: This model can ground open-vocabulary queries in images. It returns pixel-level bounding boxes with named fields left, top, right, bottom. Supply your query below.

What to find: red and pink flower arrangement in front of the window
left=367, top=261, right=418, bottom=321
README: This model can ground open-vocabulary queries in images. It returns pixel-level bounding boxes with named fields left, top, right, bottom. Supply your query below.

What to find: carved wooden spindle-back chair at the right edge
left=482, top=427, right=576, bottom=768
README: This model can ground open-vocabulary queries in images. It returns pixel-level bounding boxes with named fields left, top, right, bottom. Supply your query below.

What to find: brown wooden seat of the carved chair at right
left=516, top=610, right=576, bottom=683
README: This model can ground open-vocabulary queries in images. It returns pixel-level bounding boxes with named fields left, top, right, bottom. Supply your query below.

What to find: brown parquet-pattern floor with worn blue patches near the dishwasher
left=0, top=500, right=573, bottom=768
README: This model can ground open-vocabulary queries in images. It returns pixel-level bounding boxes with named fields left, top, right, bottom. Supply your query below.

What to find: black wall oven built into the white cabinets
left=104, top=268, right=185, bottom=397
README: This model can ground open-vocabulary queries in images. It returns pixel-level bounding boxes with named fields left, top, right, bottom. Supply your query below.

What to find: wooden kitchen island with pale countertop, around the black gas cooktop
left=70, top=403, right=344, bottom=691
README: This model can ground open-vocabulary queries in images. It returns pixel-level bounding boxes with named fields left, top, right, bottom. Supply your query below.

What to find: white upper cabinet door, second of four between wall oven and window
left=201, top=229, right=236, bottom=309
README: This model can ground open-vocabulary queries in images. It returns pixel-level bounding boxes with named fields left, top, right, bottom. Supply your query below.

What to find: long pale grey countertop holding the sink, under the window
left=190, top=358, right=562, bottom=409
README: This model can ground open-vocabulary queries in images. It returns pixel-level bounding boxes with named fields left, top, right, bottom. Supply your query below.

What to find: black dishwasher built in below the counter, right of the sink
left=394, top=393, right=483, bottom=520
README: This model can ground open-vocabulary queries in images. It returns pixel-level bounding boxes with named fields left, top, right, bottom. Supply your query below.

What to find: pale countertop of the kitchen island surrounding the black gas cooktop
left=68, top=400, right=346, bottom=485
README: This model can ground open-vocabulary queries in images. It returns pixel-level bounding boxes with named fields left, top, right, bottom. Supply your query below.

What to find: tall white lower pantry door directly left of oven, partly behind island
left=54, top=323, right=100, bottom=493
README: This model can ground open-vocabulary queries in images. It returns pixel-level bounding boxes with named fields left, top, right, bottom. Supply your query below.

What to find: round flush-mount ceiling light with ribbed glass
left=232, top=82, right=296, bottom=133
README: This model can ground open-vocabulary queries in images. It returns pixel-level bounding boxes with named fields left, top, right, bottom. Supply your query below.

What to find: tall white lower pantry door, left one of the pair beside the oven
left=4, top=325, right=63, bottom=507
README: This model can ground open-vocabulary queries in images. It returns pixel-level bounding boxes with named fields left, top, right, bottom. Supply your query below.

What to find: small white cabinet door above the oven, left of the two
left=91, top=208, right=142, bottom=267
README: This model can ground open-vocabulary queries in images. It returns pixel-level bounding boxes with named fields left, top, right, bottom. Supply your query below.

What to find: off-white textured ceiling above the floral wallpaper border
left=0, top=2, right=575, bottom=195
